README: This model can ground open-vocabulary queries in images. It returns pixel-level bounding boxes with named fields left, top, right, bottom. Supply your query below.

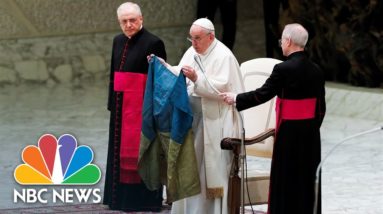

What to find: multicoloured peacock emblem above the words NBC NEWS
left=14, top=134, right=101, bottom=185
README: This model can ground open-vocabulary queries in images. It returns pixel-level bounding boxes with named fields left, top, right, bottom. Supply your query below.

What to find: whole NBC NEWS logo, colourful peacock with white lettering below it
left=13, top=134, right=101, bottom=203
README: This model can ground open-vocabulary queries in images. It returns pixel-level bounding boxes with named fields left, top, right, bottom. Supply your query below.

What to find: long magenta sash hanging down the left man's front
left=114, top=71, right=146, bottom=183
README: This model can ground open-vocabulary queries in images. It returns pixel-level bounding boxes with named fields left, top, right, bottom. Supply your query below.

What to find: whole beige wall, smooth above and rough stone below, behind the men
left=0, top=0, right=263, bottom=85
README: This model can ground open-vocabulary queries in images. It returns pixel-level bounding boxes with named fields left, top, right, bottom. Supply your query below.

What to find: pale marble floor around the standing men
left=0, top=83, right=383, bottom=214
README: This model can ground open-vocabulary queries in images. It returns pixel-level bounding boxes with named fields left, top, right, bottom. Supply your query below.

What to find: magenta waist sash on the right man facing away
left=275, top=98, right=317, bottom=132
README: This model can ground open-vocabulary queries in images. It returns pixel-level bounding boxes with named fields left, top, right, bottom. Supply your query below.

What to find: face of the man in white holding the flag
left=189, top=25, right=214, bottom=54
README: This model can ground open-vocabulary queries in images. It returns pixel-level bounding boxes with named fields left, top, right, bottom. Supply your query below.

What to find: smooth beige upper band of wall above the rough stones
left=0, top=0, right=195, bottom=39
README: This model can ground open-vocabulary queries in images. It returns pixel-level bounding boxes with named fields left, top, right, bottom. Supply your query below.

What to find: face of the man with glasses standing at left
left=118, top=10, right=143, bottom=38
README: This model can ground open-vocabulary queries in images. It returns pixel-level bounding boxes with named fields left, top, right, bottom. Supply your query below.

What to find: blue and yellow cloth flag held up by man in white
left=138, top=57, right=201, bottom=202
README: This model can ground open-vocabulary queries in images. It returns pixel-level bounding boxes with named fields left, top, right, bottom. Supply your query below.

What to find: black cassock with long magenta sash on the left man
left=104, top=28, right=166, bottom=211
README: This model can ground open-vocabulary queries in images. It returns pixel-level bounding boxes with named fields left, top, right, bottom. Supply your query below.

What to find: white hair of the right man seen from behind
left=282, top=23, right=309, bottom=48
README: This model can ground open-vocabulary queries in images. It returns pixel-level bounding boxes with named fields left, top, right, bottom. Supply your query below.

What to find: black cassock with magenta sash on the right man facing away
left=236, top=52, right=326, bottom=214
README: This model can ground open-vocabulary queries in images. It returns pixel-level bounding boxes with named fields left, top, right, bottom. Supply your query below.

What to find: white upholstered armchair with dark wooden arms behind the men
left=221, top=58, right=281, bottom=214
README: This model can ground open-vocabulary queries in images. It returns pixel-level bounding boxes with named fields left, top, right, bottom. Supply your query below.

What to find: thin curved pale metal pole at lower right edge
left=313, top=126, right=383, bottom=214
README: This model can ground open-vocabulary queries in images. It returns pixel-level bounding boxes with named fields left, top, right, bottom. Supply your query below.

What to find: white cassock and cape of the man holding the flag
left=171, top=39, right=244, bottom=214
